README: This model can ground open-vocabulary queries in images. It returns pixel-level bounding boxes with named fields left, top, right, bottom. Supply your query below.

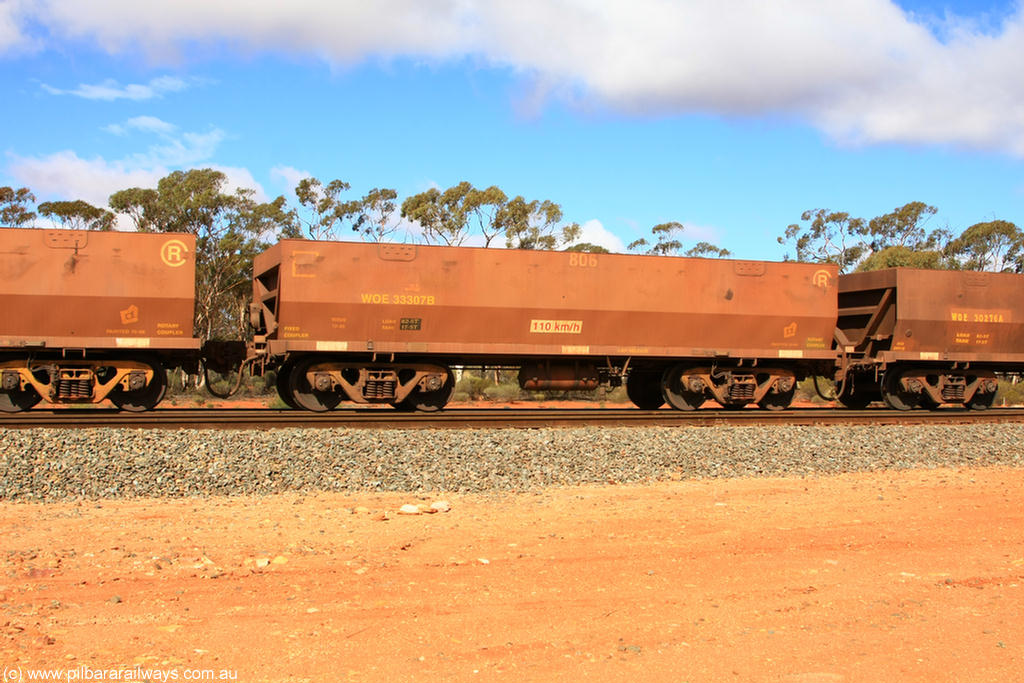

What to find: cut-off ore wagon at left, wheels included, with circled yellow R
left=0, top=228, right=200, bottom=412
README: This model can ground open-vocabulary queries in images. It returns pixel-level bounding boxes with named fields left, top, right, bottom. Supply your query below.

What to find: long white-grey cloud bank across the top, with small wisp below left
left=9, top=0, right=1024, bottom=156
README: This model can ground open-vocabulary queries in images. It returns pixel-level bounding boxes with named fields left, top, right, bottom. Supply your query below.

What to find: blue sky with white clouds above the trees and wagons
left=0, top=0, right=1024, bottom=259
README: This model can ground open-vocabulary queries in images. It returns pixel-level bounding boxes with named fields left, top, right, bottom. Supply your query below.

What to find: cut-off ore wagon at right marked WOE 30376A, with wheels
left=836, top=268, right=1024, bottom=410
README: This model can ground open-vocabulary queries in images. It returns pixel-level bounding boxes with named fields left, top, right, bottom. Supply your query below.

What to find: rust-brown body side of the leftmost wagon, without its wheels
left=0, top=228, right=199, bottom=349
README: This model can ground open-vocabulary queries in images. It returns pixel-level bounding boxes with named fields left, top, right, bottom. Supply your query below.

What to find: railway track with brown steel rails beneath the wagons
left=0, top=408, right=1024, bottom=429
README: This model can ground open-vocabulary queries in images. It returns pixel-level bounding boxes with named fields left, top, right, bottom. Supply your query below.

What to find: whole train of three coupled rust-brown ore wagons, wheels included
left=8, top=228, right=1024, bottom=412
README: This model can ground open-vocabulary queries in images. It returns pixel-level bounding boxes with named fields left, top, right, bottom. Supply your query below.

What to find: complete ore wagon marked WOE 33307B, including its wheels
left=250, top=240, right=838, bottom=411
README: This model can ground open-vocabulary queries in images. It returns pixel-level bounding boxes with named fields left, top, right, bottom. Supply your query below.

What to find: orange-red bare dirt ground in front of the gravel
left=0, top=468, right=1024, bottom=683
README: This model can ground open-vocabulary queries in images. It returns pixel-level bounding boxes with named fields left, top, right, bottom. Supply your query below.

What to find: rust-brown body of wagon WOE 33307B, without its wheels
left=257, top=241, right=836, bottom=357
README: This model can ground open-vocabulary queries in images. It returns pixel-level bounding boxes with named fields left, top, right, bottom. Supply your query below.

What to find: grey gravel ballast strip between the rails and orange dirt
left=0, top=424, right=1024, bottom=501
